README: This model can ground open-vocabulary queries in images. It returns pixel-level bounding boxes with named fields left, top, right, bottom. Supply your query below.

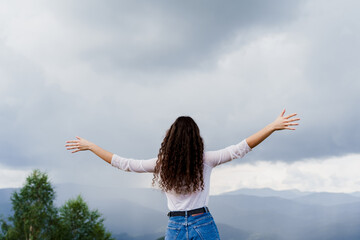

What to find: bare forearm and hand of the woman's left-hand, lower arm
left=65, top=137, right=113, bottom=164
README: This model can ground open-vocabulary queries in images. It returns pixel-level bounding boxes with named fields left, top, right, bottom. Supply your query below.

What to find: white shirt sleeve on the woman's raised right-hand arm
left=204, top=139, right=251, bottom=167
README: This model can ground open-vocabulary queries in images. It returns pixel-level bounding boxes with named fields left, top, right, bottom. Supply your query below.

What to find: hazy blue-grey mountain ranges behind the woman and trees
left=0, top=184, right=360, bottom=240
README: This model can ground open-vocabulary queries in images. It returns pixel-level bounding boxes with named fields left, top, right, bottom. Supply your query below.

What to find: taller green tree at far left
left=7, top=170, right=58, bottom=240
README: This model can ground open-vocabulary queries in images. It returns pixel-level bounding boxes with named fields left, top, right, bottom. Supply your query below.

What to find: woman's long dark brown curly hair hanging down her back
left=152, top=116, right=204, bottom=194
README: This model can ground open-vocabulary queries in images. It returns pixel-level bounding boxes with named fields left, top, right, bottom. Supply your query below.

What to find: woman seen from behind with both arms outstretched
left=65, top=109, right=300, bottom=240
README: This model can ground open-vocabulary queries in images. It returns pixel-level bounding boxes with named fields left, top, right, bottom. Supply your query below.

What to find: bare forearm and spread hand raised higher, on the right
left=246, top=109, right=300, bottom=148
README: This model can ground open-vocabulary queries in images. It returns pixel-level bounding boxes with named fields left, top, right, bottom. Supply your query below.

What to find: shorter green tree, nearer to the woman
left=59, top=195, right=113, bottom=240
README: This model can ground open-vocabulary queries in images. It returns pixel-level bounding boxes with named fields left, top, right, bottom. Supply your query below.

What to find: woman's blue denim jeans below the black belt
left=165, top=212, right=220, bottom=240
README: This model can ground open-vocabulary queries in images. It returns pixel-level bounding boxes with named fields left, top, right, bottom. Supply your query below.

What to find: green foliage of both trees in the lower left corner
left=0, top=170, right=112, bottom=240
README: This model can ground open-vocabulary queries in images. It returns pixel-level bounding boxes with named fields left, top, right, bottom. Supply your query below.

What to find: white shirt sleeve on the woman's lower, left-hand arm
left=111, top=154, right=157, bottom=173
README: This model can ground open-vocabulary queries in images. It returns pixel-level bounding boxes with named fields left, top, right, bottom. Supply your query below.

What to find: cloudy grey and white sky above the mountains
left=0, top=0, right=360, bottom=194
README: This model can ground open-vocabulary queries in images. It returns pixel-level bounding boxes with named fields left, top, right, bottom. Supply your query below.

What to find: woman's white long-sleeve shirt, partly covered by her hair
left=111, top=139, right=251, bottom=211
